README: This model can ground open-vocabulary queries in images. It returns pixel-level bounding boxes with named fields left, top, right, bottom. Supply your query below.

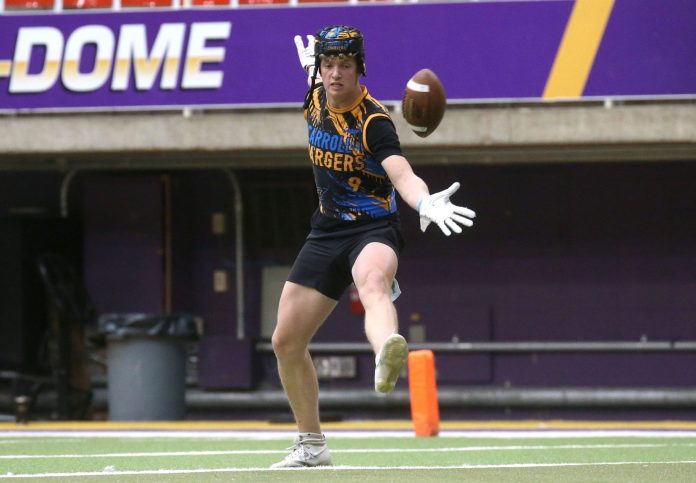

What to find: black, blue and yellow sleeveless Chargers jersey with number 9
left=304, top=86, right=400, bottom=221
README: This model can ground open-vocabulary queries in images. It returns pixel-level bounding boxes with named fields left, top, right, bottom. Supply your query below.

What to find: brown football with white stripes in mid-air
left=401, top=69, right=447, bottom=138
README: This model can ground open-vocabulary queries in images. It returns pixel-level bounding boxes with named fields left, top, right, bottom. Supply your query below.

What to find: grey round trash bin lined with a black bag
left=98, top=314, right=198, bottom=421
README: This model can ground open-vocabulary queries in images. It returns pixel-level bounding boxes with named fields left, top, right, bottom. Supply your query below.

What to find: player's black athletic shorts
left=288, top=214, right=404, bottom=300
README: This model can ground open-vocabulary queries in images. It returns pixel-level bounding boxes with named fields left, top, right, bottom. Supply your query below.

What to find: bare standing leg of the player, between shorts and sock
left=272, top=282, right=336, bottom=433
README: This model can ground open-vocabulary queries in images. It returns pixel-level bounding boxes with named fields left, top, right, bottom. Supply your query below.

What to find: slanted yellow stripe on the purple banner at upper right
left=543, top=0, right=614, bottom=99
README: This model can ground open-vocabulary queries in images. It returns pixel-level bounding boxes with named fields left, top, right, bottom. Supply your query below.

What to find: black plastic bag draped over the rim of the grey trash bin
left=98, top=313, right=199, bottom=339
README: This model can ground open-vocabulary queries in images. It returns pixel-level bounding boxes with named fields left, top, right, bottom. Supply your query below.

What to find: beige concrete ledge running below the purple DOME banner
left=0, top=102, right=696, bottom=170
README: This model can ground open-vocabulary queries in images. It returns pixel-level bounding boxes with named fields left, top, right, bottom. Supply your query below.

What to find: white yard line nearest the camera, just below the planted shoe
left=0, top=460, right=696, bottom=479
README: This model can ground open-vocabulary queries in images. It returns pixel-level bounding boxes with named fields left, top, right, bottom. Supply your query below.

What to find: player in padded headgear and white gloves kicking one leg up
left=272, top=26, right=476, bottom=468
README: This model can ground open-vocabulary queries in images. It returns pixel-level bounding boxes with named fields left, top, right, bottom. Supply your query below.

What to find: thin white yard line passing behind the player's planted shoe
left=0, top=443, right=696, bottom=460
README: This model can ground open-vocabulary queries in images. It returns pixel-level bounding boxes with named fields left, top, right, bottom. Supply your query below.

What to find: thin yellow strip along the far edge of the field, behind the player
left=0, top=420, right=696, bottom=431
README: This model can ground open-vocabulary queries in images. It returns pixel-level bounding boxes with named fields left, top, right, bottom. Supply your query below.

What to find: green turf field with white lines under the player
left=0, top=431, right=696, bottom=483
